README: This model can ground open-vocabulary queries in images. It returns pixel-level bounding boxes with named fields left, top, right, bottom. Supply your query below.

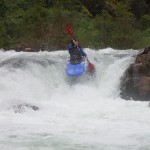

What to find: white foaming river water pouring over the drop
left=0, top=48, right=150, bottom=150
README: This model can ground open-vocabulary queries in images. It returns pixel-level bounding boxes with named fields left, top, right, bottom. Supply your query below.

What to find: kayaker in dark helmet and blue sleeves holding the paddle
left=68, top=39, right=87, bottom=64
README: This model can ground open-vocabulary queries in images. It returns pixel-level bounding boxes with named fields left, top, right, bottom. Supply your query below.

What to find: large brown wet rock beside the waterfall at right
left=120, top=47, right=150, bottom=101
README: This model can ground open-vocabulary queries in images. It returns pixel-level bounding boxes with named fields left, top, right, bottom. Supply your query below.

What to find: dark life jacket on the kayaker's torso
left=70, top=47, right=82, bottom=64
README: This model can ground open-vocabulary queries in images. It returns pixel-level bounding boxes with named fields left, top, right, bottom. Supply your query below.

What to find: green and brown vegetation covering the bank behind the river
left=0, top=0, right=150, bottom=50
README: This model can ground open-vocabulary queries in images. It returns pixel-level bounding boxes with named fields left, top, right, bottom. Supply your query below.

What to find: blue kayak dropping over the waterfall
left=66, top=61, right=86, bottom=77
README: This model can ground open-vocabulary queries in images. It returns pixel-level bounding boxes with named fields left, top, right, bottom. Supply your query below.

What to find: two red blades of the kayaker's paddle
left=66, top=24, right=95, bottom=72
